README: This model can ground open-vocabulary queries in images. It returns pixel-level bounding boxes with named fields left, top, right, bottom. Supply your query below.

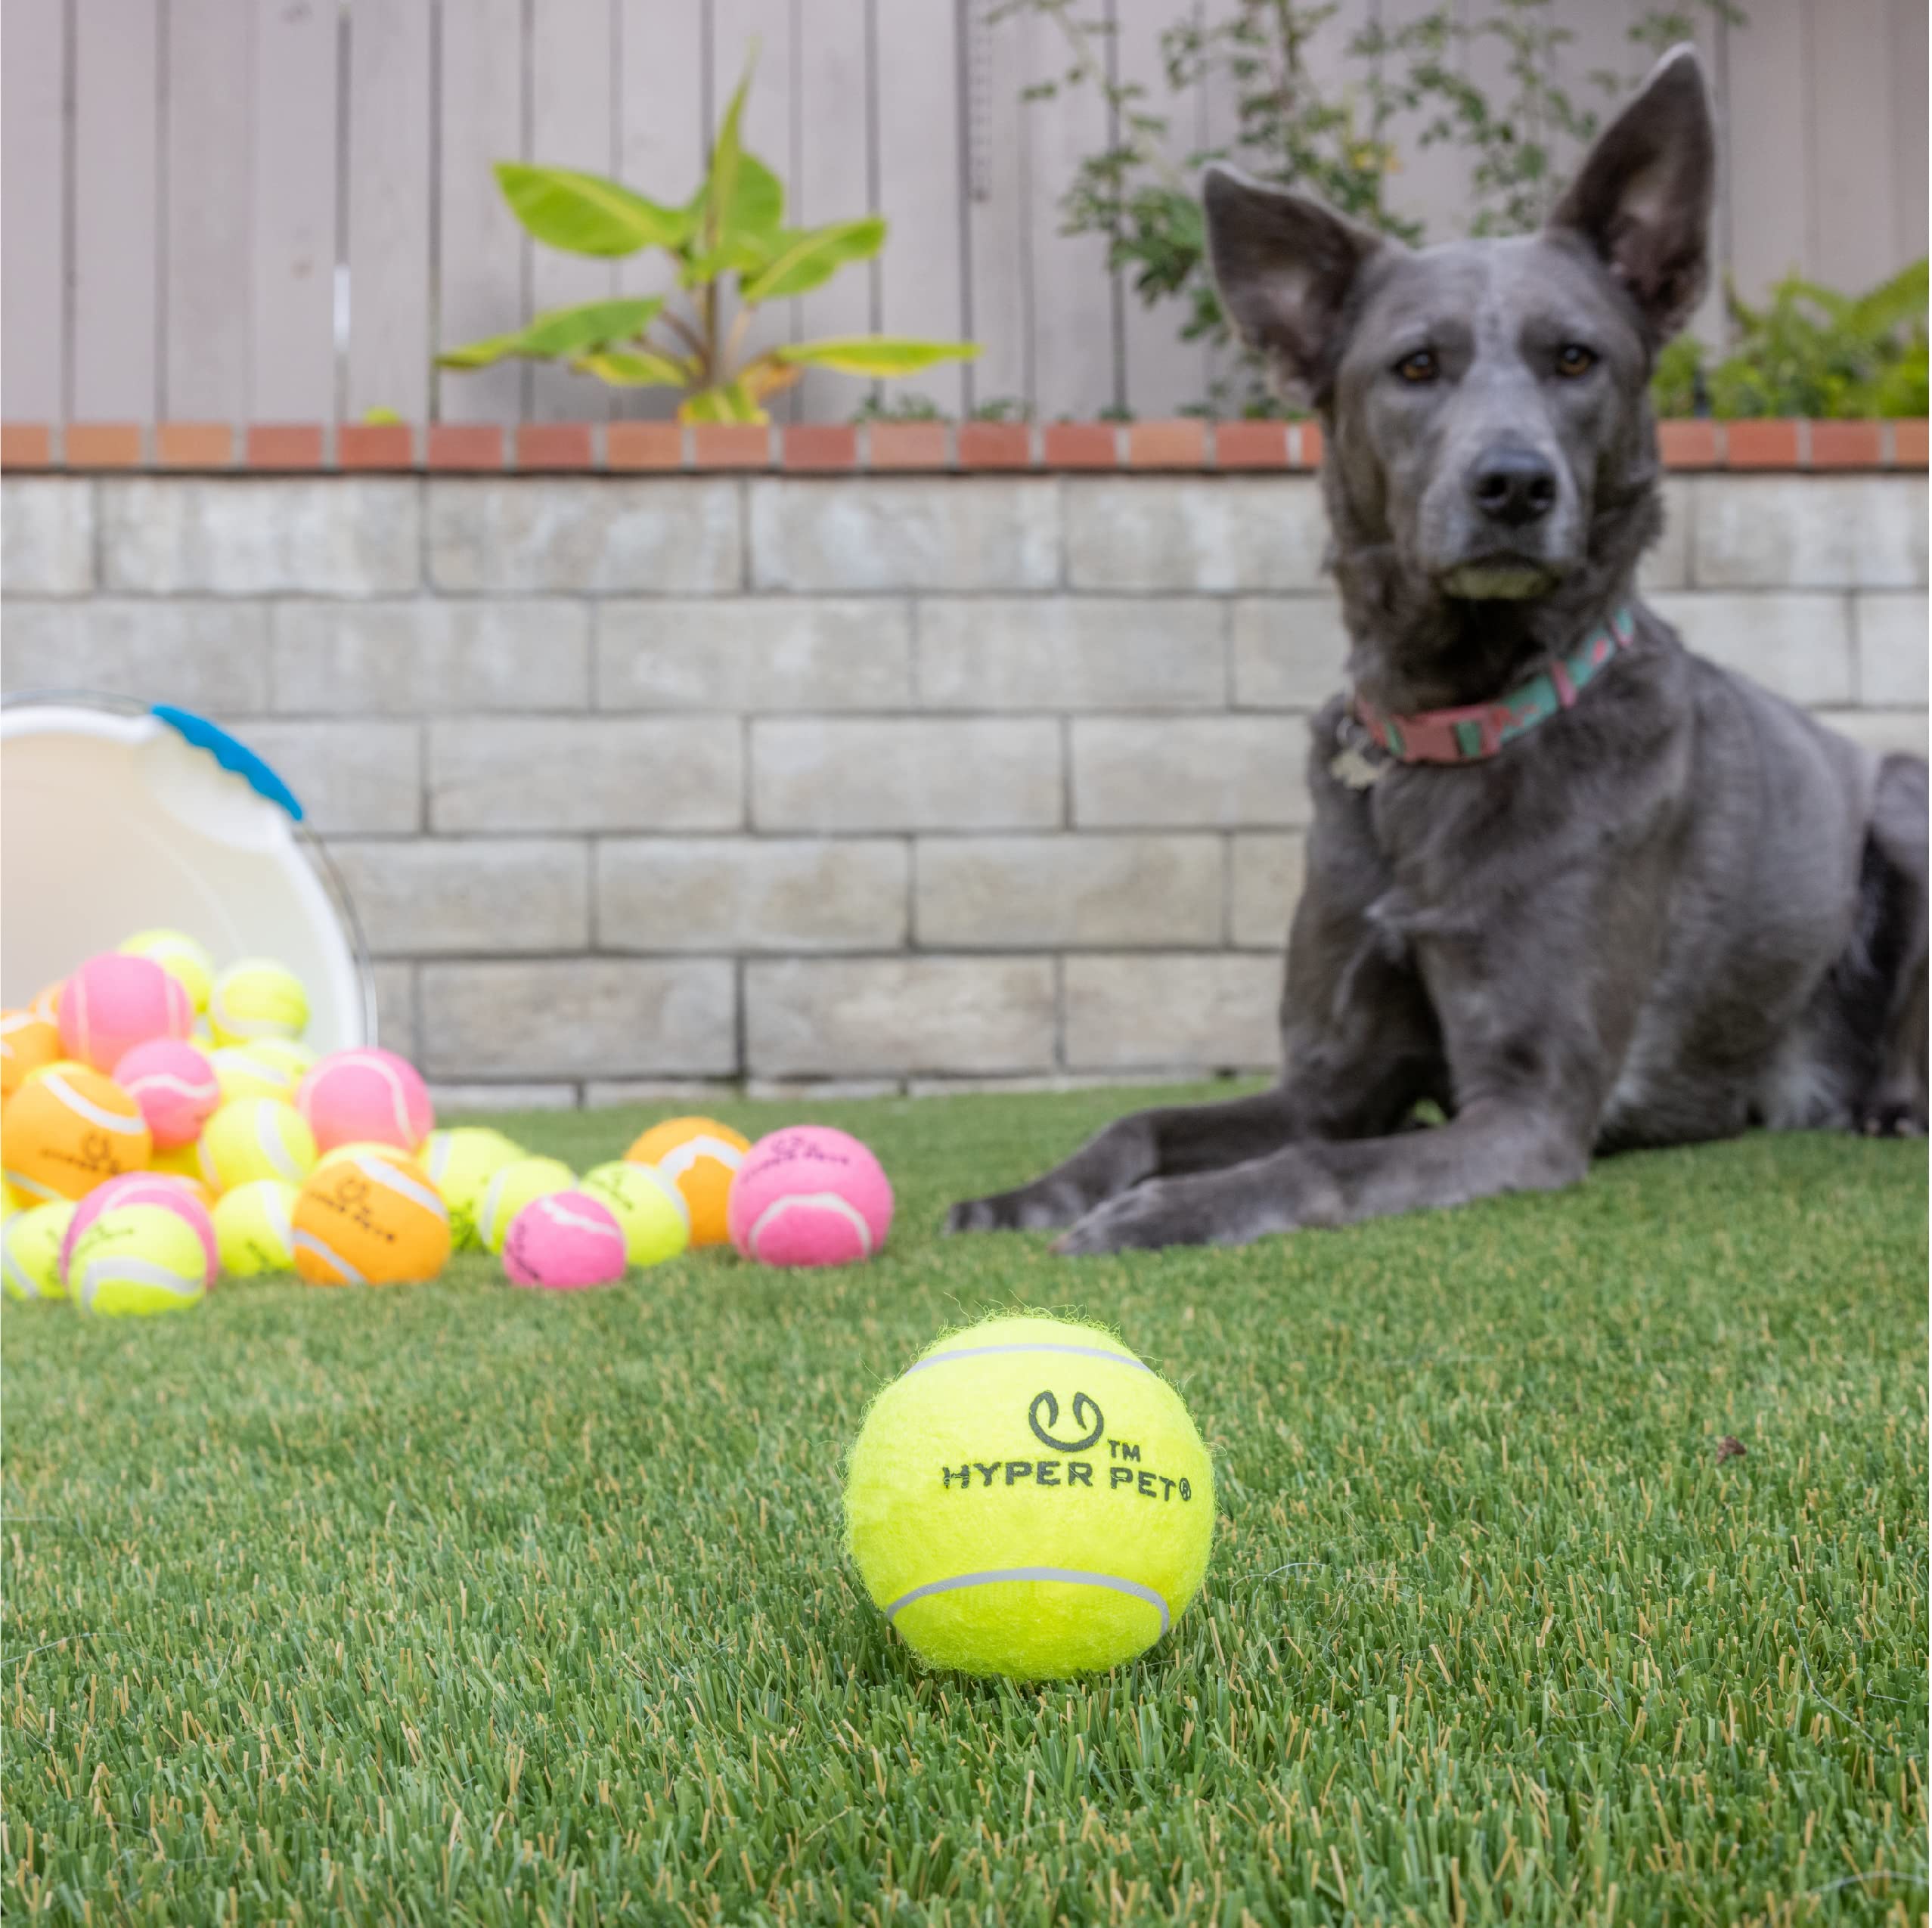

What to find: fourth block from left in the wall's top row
left=748, top=476, right=1059, bottom=593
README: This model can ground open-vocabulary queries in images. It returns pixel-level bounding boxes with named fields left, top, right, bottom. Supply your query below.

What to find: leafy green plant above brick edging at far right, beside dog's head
left=1652, top=259, right=1926, bottom=419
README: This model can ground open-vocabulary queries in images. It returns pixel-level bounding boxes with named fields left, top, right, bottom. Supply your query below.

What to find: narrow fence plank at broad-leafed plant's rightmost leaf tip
left=962, top=0, right=1034, bottom=410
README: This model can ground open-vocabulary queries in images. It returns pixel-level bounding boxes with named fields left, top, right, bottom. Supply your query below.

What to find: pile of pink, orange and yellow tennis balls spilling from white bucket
left=0, top=931, right=892, bottom=1316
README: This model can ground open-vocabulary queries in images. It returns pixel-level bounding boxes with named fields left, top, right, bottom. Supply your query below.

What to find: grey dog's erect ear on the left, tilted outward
left=1202, top=166, right=1383, bottom=394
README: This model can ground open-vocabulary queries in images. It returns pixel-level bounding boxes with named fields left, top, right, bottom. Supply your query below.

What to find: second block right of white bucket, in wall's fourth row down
left=597, top=836, right=906, bottom=950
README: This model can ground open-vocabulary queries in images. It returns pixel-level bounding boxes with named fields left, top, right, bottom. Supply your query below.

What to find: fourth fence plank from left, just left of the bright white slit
left=250, top=0, right=340, bottom=421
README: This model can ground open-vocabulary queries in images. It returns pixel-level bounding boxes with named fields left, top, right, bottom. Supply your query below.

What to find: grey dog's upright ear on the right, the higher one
left=1549, top=42, right=1717, bottom=344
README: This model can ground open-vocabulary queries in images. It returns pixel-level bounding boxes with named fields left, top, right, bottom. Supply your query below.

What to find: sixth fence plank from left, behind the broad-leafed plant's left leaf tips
left=435, top=0, right=523, bottom=421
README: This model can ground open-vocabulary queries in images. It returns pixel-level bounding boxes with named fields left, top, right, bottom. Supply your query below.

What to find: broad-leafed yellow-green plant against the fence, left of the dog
left=436, top=66, right=979, bottom=421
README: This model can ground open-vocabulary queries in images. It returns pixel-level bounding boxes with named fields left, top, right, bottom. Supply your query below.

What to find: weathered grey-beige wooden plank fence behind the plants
left=0, top=0, right=1926, bottom=421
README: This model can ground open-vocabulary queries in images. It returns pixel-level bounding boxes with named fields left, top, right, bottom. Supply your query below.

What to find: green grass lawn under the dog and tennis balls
left=0, top=1093, right=1926, bottom=1924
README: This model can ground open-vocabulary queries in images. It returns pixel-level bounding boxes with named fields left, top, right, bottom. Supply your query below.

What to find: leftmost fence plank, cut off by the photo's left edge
left=0, top=0, right=67, bottom=421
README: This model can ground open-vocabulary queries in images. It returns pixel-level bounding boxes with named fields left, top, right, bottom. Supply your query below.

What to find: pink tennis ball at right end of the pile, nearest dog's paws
left=724, top=1124, right=892, bottom=1266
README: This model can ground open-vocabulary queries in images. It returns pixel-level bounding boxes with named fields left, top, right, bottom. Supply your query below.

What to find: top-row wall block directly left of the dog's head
left=1065, top=476, right=1327, bottom=591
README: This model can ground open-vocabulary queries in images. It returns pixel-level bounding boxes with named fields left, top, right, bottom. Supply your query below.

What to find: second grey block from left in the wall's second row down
left=274, top=597, right=591, bottom=714
